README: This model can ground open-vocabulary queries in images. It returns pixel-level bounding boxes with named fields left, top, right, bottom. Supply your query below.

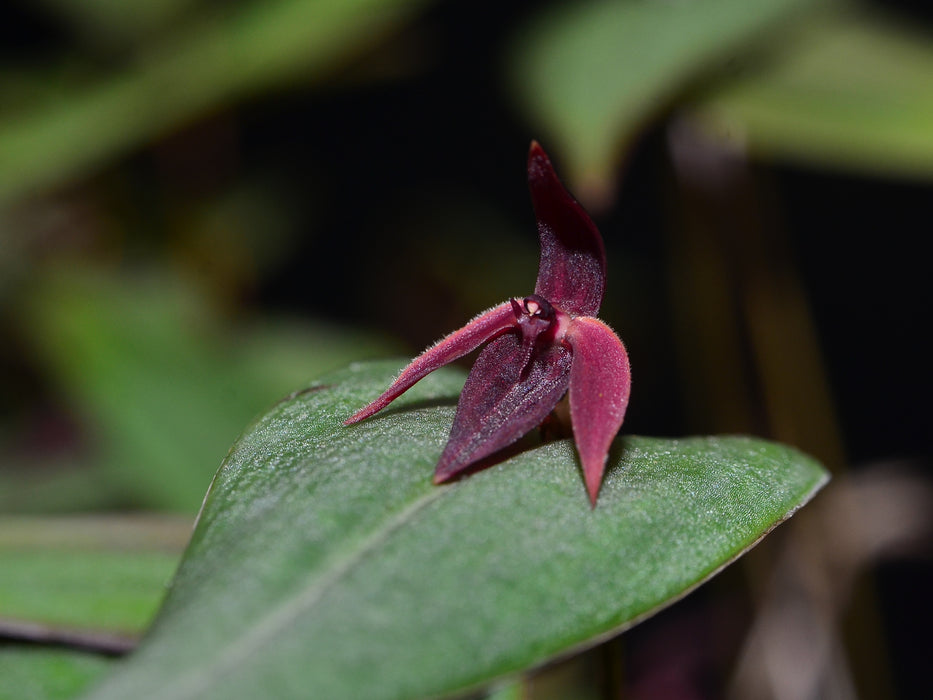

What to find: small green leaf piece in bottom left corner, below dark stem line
left=0, top=645, right=114, bottom=700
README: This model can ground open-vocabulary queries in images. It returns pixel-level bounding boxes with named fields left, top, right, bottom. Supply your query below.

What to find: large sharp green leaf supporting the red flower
left=83, top=363, right=827, bottom=700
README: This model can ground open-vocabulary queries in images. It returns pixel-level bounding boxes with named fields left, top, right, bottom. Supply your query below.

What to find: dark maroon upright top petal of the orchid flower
left=528, top=141, right=606, bottom=316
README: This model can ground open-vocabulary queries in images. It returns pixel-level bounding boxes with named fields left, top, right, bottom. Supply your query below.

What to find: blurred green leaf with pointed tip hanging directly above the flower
left=510, top=0, right=821, bottom=196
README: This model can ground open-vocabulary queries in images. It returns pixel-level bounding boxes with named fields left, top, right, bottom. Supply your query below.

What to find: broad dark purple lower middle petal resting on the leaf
left=434, top=333, right=570, bottom=484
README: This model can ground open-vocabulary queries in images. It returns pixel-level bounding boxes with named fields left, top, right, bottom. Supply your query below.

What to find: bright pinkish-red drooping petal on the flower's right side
left=565, top=317, right=631, bottom=506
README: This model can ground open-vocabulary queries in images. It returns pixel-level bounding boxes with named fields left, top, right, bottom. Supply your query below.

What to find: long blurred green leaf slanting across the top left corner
left=0, top=0, right=436, bottom=206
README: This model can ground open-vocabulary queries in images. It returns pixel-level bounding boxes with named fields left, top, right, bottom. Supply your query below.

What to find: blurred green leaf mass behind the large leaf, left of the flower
left=21, top=270, right=385, bottom=511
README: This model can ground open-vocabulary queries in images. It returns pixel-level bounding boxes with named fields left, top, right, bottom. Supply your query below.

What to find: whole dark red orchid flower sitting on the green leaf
left=345, top=142, right=631, bottom=506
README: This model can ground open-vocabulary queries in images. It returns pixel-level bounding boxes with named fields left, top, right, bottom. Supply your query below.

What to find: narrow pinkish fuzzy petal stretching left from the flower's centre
left=344, top=301, right=517, bottom=425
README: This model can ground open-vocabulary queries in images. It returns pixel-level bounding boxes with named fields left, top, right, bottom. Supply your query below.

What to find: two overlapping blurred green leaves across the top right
left=512, top=0, right=933, bottom=203
